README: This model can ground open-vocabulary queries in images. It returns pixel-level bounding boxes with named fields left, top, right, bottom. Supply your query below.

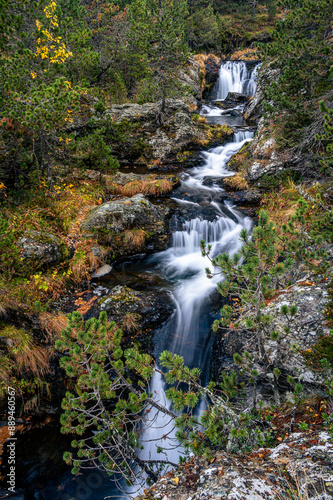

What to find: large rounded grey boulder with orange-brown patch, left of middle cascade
left=82, top=194, right=168, bottom=257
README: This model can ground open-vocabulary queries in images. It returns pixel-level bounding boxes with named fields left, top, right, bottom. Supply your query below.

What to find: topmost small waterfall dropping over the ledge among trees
left=218, top=61, right=259, bottom=100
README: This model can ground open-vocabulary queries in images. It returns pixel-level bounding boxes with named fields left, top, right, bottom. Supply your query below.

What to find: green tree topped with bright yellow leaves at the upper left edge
left=0, top=1, right=86, bottom=193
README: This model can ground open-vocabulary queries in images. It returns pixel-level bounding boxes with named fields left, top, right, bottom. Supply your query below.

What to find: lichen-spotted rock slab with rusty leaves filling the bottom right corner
left=139, top=431, right=333, bottom=500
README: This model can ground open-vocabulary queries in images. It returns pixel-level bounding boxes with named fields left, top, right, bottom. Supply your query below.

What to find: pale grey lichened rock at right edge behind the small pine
left=212, top=280, right=330, bottom=390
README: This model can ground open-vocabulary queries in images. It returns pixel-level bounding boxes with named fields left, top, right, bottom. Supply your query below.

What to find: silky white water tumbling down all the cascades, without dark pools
left=122, top=62, right=255, bottom=500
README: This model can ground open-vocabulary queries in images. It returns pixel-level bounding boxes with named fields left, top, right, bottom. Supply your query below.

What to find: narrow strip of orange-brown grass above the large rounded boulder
left=108, top=179, right=173, bottom=197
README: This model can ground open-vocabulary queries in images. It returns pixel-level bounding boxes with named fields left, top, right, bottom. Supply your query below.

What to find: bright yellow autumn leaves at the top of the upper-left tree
left=31, top=1, right=73, bottom=66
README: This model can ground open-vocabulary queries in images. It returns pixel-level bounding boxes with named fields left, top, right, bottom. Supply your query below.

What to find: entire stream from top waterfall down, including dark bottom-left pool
left=1, top=61, right=257, bottom=500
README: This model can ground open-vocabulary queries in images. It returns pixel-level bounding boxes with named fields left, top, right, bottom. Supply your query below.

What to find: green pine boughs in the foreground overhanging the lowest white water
left=56, top=312, right=272, bottom=483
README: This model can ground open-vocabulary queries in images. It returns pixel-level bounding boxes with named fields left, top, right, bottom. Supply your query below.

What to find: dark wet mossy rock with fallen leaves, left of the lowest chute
left=99, top=285, right=173, bottom=333
